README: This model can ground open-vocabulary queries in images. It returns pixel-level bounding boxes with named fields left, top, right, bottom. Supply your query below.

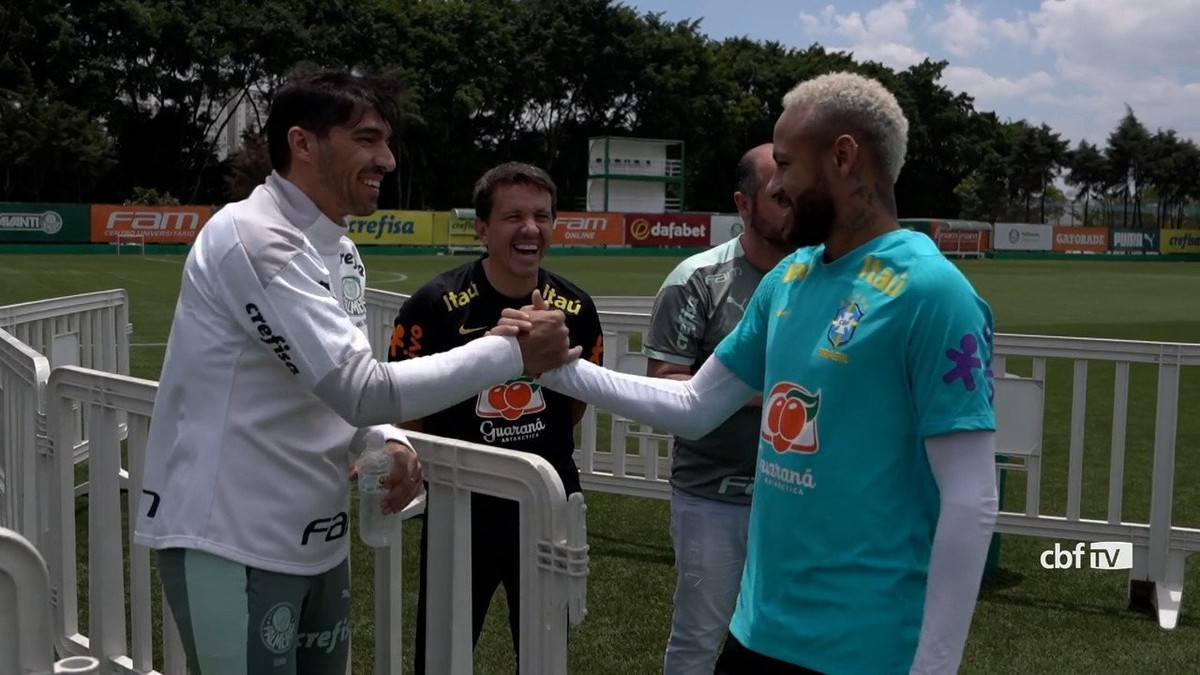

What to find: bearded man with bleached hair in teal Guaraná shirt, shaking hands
left=528, top=73, right=996, bottom=675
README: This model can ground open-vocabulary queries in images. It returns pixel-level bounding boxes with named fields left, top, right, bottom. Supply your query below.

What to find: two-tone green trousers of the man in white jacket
left=158, top=549, right=350, bottom=675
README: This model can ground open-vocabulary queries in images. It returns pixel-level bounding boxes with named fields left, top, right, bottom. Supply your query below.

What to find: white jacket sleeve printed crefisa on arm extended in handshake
left=208, top=234, right=523, bottom=426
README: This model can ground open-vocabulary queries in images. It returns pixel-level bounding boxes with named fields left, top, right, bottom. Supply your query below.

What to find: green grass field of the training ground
left=0, top=252, right=1200, bottom=674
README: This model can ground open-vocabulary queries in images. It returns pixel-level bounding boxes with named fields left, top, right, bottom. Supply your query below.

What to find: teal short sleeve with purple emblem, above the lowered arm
left=906, top=257, right=996, bottom=438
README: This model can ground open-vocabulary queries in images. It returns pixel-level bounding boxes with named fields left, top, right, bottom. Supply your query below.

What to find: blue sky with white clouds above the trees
left=623, top=0, right=1200, bottom=148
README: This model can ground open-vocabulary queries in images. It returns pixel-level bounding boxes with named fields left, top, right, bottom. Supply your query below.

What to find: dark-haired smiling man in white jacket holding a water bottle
left=134, top=72, right=577, bottom=675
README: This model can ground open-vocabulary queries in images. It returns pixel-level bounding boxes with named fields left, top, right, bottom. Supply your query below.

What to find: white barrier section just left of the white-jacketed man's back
left=40, top=366, right=186, bottom=675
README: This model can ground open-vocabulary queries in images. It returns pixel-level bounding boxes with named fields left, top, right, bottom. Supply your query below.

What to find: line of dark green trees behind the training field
left=0, top=0, right=1200, bottom=227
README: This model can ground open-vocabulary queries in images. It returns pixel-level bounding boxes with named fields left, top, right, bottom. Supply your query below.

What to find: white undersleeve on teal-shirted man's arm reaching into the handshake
left=539, top=348, right=757, bottom=438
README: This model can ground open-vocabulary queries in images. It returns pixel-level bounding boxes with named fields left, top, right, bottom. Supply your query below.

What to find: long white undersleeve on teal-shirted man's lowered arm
left=912, top=431, right=997, bottom=675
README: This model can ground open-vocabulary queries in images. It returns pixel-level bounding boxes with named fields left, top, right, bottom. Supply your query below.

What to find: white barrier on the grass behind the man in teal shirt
left=576, top=312, right=1200, bottom=629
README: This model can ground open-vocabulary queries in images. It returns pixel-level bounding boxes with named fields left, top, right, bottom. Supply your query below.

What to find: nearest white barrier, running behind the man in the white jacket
left=38, top=366, right=588, bottom=675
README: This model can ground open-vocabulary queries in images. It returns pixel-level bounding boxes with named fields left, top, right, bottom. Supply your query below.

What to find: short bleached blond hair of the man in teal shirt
left=784, top=72, right=908, bottom=183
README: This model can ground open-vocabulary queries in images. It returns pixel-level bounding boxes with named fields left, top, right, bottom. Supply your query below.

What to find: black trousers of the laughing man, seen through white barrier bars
left=413, top=494, right=521, bottom=675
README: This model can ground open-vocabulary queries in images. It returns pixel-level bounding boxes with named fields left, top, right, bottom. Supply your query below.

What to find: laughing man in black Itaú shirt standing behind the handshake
left=388, top=162, right=604, bottom=674
